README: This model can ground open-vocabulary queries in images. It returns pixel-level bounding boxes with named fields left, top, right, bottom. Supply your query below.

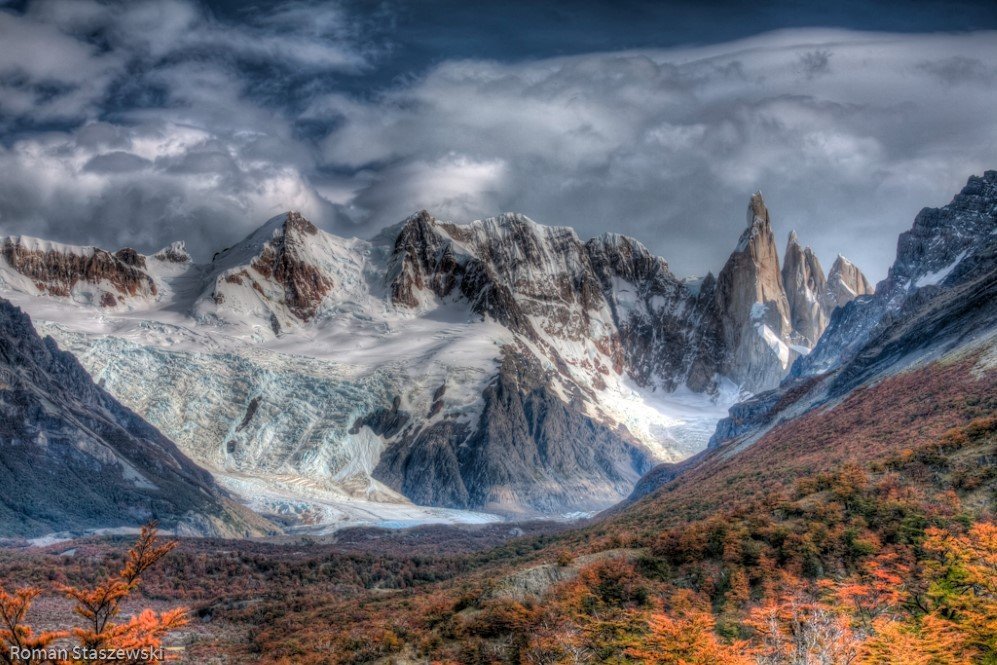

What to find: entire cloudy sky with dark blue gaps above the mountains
left=0, top=0, right=997, bottom=279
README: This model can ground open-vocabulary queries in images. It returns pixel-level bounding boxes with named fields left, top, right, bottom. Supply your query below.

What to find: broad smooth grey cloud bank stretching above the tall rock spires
left=318, top=30, right=997, bottom=277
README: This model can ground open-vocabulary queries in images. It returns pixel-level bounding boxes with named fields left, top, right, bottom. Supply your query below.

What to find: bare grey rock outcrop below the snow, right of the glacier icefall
left=374, top=348, right=652, bottom=515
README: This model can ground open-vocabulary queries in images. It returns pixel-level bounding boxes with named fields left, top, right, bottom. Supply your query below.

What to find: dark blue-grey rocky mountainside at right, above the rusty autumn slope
left=710, top=171, right=997, bottom=456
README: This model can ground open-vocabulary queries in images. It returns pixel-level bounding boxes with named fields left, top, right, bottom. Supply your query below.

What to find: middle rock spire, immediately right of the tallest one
left=782, top=231, right=830, bottom=347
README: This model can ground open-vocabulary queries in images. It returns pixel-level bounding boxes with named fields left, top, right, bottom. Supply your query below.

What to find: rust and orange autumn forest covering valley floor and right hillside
left=0, top=347, right=997, bottom=665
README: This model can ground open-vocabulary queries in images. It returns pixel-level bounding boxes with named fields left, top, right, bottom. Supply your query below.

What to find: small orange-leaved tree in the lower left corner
left=0, top=523, right=187, bottom=665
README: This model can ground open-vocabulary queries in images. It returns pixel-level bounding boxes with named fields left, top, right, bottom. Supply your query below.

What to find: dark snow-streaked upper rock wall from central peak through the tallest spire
left=388, top=202, right=848, bottom=400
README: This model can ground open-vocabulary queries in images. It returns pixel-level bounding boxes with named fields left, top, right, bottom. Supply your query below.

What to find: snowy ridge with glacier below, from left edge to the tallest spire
left=0, top=195, right=872, bottom=521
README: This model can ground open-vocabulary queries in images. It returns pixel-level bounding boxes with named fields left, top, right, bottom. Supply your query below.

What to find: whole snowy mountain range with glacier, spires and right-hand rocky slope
left=0, top=172, right=997, bottom=526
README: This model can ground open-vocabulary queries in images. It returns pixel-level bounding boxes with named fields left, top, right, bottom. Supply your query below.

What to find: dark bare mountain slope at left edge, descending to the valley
left=0, top=299, right=266, bottom=536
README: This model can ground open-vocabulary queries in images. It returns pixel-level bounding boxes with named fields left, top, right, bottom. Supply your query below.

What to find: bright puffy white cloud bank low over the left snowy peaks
left=0, top=118, right=331, bottom=253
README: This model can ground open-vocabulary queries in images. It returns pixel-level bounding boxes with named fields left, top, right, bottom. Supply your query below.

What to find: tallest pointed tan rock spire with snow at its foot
left=715, top=192, right=796, bottom=392
